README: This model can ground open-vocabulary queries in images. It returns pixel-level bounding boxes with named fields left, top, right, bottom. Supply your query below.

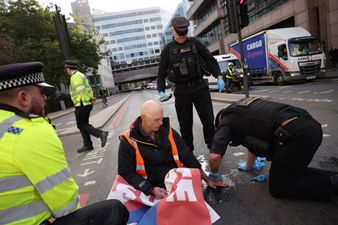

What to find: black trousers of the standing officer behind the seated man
left=174, top=80, right=215, bottom=151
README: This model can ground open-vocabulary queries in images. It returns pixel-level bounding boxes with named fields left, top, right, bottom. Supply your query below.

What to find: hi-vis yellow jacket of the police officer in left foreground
left=0, top=105, right=80, bottom=225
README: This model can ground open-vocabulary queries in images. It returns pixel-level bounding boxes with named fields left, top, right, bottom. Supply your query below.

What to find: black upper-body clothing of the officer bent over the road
left=210, top=99, right=308, bottom=157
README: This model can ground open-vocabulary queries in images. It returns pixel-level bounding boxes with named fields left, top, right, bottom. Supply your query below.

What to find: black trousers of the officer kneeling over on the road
left=269, top=115, right=336, bottom=200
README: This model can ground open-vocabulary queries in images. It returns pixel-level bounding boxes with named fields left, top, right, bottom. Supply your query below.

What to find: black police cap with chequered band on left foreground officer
left=0, top=62, right=53, bottom=91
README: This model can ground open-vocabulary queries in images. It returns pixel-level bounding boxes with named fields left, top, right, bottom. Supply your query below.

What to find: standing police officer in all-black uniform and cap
left=157, top=16, right=221, bottom=151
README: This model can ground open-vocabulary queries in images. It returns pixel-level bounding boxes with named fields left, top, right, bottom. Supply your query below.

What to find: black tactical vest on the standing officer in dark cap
left=167, top=39, right=203, bottom=83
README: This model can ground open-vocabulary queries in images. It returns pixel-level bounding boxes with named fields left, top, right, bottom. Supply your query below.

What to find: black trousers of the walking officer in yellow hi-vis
left=75, top=105, right=102, bottom=146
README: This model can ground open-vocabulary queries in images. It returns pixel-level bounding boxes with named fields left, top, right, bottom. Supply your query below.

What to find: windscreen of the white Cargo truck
left=289, top=37, right=323, bottom=57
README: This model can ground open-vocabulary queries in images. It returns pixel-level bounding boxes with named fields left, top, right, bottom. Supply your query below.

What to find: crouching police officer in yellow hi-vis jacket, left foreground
left=0, top=62, right=129, bottom=225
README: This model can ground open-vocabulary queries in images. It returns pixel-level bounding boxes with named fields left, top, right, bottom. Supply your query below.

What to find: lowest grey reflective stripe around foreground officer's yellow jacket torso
left=0, top=201, right=49, bottom=224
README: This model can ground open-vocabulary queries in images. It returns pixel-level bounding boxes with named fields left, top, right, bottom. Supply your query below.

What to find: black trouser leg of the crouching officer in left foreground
left=53, top=199, right=129, bottom=225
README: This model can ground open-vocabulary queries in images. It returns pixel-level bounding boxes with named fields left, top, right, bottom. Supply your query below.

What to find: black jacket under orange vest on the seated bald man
left=118, top=117, right=201, bottom=195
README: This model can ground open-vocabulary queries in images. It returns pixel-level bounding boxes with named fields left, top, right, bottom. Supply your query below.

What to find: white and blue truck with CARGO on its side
left=230, top=27, right=326, bottom=85
